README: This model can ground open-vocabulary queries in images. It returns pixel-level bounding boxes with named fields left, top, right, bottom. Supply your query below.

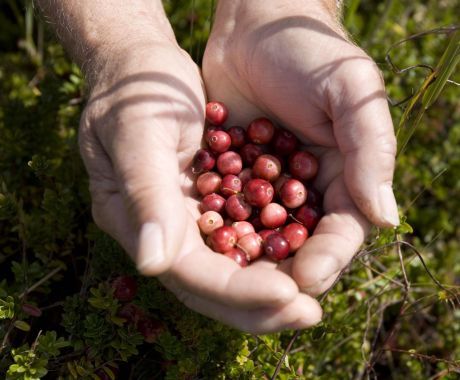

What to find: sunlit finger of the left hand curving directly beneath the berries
left=161, top=217, right=298, bottom=309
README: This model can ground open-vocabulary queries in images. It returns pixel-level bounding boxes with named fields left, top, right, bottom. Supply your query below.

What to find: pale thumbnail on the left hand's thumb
left=137, top=223, right=165, bottom=272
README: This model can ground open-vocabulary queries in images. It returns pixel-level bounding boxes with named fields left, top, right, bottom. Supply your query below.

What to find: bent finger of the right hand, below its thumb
left=291, top=177, right=370, bottom=294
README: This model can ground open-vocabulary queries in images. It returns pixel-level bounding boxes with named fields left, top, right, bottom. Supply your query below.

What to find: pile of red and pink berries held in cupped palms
left=192, top=102, right=322, bottom=267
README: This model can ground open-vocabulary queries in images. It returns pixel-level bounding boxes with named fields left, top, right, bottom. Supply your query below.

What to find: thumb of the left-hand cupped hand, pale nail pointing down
left=114, top=140, right=187, bottom=276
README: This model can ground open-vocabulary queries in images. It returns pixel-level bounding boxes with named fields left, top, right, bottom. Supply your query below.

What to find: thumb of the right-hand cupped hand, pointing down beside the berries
left=330, top=57, right=399, bottom=227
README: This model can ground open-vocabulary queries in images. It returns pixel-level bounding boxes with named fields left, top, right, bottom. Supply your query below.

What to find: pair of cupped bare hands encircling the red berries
left=80, top=2, right=398, bottom=333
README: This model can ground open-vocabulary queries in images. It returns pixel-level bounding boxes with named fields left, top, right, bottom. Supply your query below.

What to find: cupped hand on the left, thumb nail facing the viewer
left=80, top=39, right=321, bottom=333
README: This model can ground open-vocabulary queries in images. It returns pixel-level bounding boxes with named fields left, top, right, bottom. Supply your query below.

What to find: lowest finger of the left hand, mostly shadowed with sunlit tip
left=170, top=288, right=322, bottom=334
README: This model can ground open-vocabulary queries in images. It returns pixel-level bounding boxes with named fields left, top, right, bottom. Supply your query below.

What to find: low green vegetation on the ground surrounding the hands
left=0, top=0, right=460, bottom=380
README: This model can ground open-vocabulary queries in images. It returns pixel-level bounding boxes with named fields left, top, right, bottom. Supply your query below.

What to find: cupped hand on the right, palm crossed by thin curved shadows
left=203, top=0, right=399, bottom=295
